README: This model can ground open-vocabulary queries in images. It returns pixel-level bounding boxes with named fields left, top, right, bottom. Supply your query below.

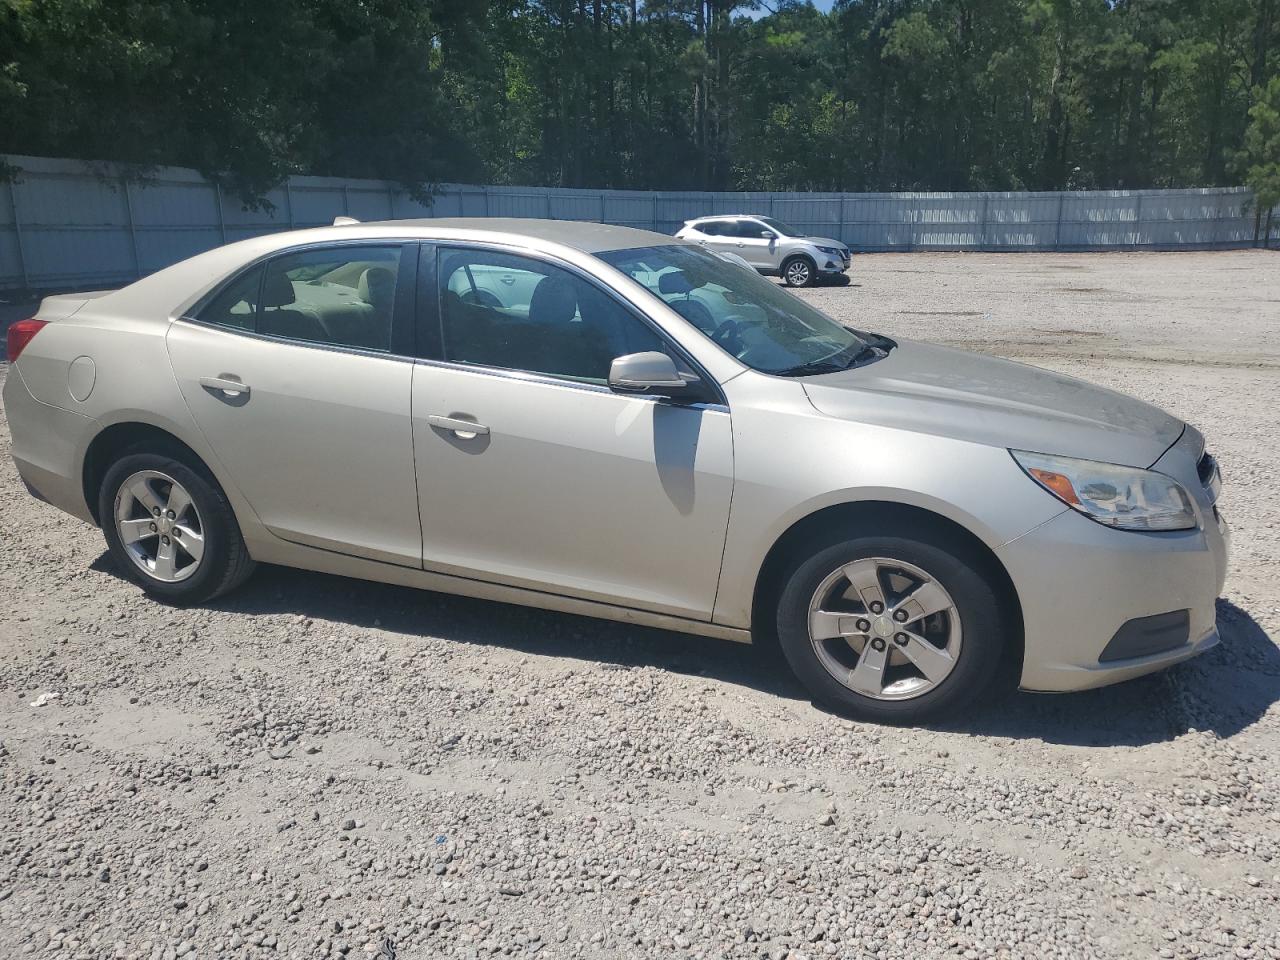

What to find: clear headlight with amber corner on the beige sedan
left=1009, top=451, right=1196, bottom=530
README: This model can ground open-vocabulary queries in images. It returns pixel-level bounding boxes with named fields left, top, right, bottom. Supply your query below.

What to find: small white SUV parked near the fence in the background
left=676, top=216, right=850, bottom=287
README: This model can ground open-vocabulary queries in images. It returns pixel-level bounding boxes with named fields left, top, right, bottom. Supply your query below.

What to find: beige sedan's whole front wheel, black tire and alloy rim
left=777, top=534, right=1010, bottom=723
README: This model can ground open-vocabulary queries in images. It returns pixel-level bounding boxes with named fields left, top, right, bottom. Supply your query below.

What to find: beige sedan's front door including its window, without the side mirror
left=412, top=247, right=733, bottom=621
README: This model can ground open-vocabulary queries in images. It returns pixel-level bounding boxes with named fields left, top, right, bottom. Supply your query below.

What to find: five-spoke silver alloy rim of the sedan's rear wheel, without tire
left=115, top=470, right=205, bottom=584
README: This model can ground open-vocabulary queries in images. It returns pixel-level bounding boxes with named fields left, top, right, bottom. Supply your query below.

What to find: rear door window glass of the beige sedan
left=200, top=244, right=401, bottom=351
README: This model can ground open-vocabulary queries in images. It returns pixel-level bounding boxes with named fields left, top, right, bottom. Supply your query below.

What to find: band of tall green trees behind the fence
left=0, top=0, right=1280, bottom=204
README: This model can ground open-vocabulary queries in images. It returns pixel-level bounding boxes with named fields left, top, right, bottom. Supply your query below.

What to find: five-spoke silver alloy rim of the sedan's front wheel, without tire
left=809, top=557, right=961, bottom=700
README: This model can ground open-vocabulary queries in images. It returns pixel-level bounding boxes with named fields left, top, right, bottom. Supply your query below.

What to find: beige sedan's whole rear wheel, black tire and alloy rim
left=97, top=452, right=256, bottom=605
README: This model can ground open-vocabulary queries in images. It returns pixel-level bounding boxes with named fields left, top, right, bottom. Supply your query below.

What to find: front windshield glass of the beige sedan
left=596, top=243, right=877, bottom=376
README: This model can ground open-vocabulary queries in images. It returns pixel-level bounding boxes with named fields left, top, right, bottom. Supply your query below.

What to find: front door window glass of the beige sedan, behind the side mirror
left=438, top=248, right=669, bottom=384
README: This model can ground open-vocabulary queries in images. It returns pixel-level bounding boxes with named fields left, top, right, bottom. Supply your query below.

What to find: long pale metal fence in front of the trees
left=0, top=156, right=1280, bottom=289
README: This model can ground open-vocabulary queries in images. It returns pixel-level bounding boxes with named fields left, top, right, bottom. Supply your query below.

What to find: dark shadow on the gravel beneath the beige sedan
left=93, top=553, right=1280, bottom=746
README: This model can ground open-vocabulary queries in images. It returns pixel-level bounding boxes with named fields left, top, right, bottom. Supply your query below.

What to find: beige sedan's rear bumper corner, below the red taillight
left=4, top=364, right=99, bottom=524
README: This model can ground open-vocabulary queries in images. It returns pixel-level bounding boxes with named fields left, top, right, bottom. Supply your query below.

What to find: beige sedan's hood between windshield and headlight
left=801, top=340, right=1184, bottom=467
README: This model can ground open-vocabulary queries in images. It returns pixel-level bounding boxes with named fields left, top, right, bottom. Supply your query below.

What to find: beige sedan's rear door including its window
left=168, top=242, right=421, bottom=567
